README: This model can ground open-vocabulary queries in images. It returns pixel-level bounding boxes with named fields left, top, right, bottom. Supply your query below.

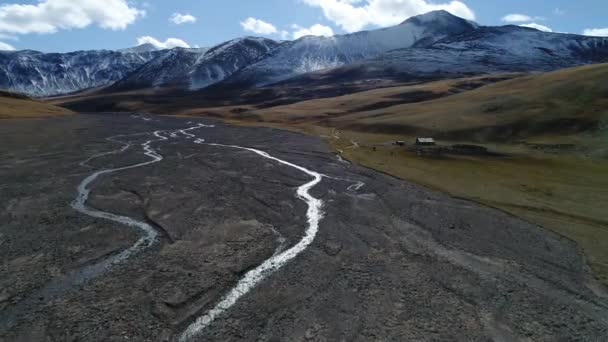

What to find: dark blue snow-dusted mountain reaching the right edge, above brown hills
left=308, top=26, right=608, bottom=82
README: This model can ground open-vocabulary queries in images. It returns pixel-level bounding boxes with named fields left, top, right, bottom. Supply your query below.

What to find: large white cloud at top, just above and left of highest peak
left=302, top=0, right=475, bottom=32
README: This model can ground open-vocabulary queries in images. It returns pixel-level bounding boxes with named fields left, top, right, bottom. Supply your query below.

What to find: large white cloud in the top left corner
left=0, top=0, right=145, bottom=34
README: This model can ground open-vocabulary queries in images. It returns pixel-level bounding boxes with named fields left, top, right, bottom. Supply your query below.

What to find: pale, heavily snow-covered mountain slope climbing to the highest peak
left=221, top=11, right=478, bottom=85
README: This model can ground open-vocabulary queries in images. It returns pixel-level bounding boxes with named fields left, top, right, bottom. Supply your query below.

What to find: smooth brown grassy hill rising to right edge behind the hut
left=340, top=64, right=608, bottom=141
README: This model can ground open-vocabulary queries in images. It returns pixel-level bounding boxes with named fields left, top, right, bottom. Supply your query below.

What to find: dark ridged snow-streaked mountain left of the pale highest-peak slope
left=110, top=37, right=279, bottom=90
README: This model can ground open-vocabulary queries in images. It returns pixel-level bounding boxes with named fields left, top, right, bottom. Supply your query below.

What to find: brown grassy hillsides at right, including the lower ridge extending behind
left=252, top=64, right=608, bottom=142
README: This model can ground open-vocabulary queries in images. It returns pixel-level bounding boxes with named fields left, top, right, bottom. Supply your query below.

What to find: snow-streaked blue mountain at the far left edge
left=0, top=46, right=161, bottom=96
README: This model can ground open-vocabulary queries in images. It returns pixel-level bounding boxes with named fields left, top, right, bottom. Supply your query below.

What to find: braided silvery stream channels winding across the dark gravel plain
left=72, top=120, right=364, bottom=341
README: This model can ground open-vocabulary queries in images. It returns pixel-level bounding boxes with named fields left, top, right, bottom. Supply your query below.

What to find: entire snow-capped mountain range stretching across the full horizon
left=0, top=11, right=608, bottom=96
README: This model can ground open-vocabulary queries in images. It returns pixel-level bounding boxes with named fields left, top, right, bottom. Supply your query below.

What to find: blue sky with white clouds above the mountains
left=0, top=0, right=608, bottom=52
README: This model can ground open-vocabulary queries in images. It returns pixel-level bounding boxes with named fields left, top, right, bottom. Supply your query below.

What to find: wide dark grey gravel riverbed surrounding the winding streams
left=0, top=115, right=608, bottom=341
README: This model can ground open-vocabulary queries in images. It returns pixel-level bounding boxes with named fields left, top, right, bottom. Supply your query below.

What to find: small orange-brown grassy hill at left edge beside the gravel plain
left=0, top=91, right=72, bottom=119
